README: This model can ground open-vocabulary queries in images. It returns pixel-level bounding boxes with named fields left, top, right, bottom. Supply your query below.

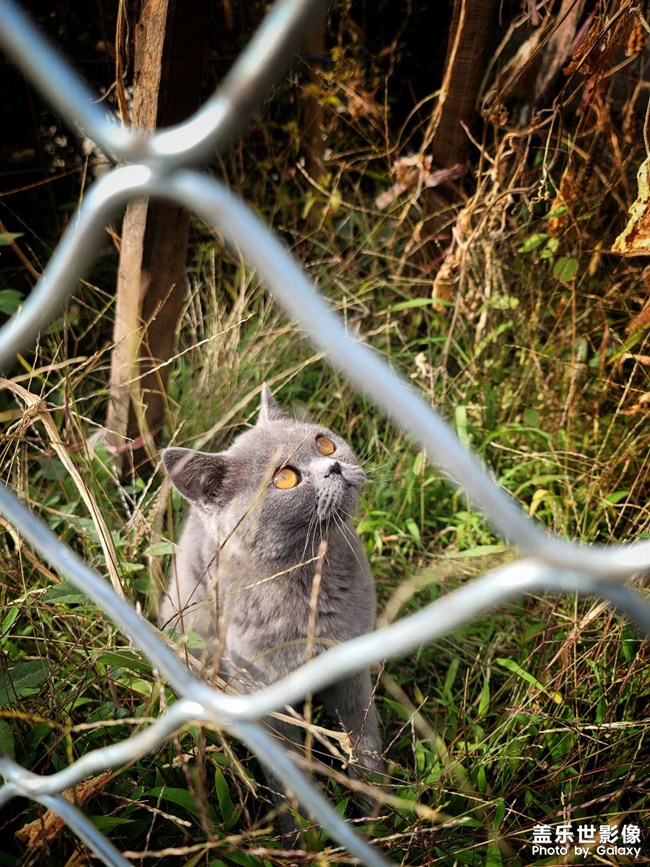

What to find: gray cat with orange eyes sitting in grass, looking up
left=160, top=387, right=381, bottom=828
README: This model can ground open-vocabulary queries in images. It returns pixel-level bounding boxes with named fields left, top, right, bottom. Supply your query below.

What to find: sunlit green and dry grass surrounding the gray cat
left=0, top=122, right=650, bottom=867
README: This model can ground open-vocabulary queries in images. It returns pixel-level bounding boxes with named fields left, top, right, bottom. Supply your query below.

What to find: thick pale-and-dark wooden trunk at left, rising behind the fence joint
left=107, top=0, right=212, bottom=471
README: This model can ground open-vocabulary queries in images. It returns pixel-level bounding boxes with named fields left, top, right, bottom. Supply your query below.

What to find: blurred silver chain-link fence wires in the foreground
left=0, top=0, right=650, bottom=865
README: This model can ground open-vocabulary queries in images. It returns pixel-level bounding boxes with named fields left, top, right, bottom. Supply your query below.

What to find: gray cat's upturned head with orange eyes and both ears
left=162, top=387, right=365, bottom=559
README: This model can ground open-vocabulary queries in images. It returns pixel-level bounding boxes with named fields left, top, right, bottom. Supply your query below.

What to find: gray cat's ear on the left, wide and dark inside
left=162, top=448, right=228, bottom=508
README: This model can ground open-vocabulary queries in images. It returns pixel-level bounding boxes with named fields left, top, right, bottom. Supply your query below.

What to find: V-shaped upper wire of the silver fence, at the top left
left=0, top=0, right=327, bottom=167
